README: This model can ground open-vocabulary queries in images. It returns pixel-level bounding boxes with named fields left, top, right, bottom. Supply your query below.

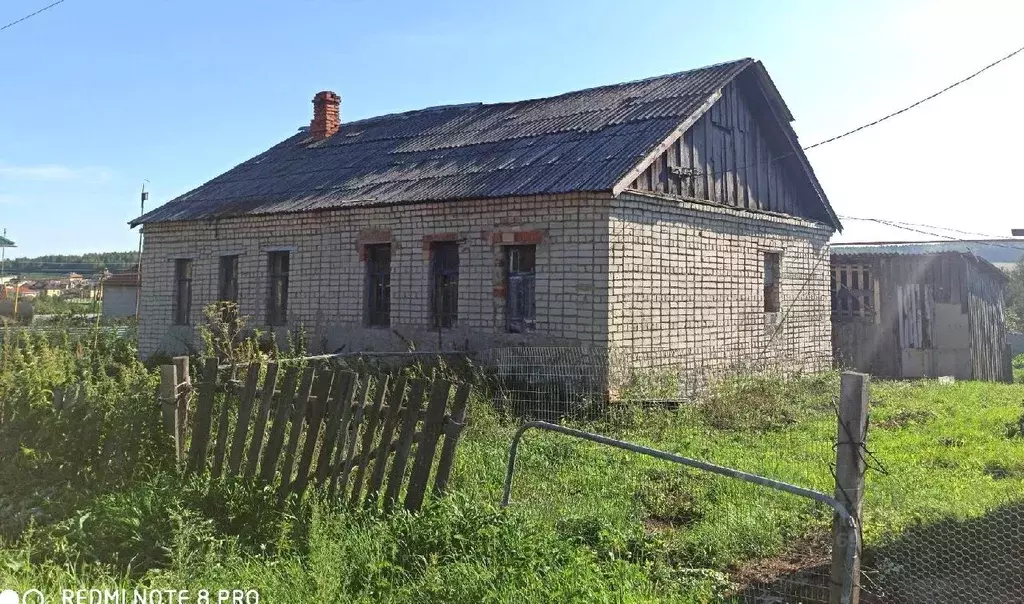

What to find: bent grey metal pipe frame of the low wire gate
left=502, top=422, right=859, bottom=604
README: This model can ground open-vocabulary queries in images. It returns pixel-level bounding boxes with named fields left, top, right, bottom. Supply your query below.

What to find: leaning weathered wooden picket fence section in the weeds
left=161, top=357, right=470, bottom=511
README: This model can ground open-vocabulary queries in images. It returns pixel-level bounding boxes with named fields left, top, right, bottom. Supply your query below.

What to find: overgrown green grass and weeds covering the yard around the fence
left=0, top=331, right=1024, bottom=602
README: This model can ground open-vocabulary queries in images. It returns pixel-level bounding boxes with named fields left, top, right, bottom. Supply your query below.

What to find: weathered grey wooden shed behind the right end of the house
left=831, top=242, right=1011, bottom=381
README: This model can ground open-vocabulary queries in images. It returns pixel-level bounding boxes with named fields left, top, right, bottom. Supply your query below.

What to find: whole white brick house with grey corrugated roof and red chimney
left=131, top=58, right=841, bottom=389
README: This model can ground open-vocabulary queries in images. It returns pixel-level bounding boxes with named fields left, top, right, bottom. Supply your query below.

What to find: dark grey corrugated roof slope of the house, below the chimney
left=131, top=58, right=823, bottom=226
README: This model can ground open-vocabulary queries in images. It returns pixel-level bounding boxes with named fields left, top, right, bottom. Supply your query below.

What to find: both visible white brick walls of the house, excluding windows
left=139, top=192, right=831, bottom=393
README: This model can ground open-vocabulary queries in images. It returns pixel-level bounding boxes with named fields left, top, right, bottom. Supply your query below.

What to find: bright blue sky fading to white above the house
left=0, top=0, right=1024, bottom=256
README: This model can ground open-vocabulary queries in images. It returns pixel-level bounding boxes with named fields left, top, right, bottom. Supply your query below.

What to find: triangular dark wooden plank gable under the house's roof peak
left=631, top=82, right=822, bottom=219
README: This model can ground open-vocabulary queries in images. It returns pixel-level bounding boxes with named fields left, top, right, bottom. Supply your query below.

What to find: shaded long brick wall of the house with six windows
left=139, top=195, right=608, bottom=356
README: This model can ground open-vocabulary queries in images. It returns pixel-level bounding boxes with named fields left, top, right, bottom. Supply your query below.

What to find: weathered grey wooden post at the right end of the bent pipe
left=829, top=372, right=869, bottom=604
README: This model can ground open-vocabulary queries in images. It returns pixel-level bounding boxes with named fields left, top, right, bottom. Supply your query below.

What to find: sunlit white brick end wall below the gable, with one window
left=608, top=193, right=831, bottom=393
